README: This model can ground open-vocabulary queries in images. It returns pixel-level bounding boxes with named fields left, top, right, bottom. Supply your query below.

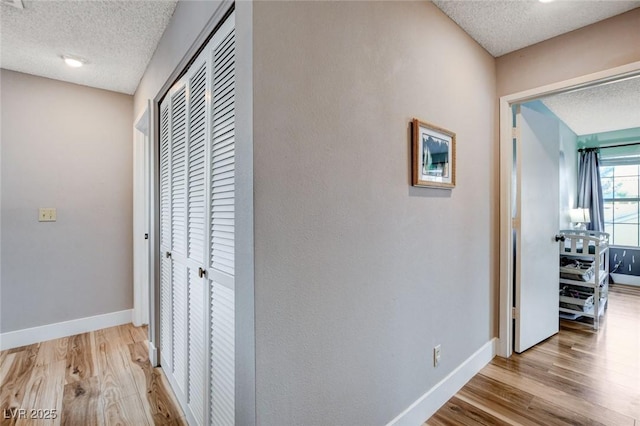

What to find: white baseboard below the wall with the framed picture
left=387, top=337, right=498, bottom=426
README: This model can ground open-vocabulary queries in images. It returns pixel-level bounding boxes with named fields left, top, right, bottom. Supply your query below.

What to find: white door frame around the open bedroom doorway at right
left=497, top=61, right=640, bottom=358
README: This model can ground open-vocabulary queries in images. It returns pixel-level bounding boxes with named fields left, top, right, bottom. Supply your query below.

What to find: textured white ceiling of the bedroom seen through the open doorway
left=542, top=77, right=640, bottom=136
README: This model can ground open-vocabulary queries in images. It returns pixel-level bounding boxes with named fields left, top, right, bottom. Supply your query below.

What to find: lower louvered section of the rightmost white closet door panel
left=211, top=281, right=235, bottom=426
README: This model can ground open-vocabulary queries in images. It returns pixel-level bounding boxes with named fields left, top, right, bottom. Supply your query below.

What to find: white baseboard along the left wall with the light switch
left=0, top=309, right=132, bottom=350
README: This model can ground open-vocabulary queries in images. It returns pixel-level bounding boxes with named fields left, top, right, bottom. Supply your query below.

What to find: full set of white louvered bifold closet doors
left=160, top=10, right=235, bottom=425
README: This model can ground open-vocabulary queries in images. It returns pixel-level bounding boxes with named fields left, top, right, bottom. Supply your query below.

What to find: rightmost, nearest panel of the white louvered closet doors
left=209, top=17, right=235, bottom=425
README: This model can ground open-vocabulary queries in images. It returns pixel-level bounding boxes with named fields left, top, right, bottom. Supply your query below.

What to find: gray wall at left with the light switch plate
left=0, top=70, right=133, bottom=332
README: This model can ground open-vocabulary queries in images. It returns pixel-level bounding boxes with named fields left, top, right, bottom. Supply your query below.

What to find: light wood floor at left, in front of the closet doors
left=0, top=324, right=186, bottom=426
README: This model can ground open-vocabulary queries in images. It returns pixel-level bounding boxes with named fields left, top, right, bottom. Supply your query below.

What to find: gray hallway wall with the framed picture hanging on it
left=253, top=2, right=498, bottom=425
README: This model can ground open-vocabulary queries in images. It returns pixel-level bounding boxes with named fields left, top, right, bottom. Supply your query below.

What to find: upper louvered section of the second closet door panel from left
left=171, top=87, right=187, bottom=254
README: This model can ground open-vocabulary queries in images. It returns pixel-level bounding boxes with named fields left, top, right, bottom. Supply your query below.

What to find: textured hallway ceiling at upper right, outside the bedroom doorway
left=433, top=0, right=640, bottom=57
